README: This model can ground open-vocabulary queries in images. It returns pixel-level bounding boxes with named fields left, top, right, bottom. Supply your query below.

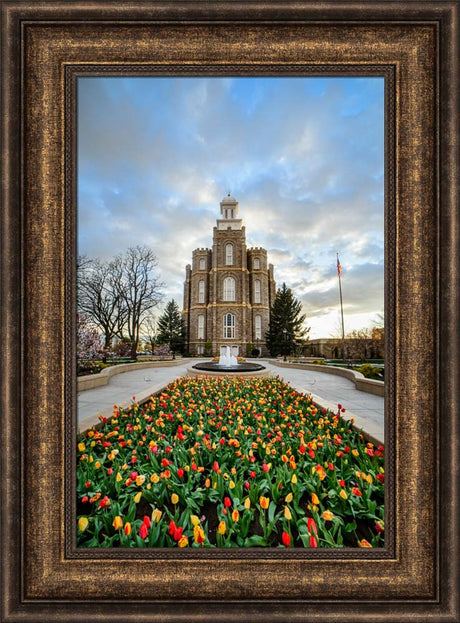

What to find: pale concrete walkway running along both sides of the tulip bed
left=78, top=359, right=384, bottom=443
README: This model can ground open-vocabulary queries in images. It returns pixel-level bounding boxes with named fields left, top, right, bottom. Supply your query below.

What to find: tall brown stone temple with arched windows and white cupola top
left=182, top=194, right=276, bottom=357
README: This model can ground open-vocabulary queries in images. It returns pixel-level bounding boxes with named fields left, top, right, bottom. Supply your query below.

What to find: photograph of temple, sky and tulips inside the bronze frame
left=77, top=73, right=386, bottom=556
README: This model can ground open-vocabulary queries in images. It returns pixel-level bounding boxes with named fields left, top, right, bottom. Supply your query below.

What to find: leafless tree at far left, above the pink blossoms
left=77, top=256, right=127, bottom=349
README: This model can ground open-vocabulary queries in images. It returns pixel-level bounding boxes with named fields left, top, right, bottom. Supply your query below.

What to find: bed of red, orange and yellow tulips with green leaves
left=77, top=378, right=384, bottom=547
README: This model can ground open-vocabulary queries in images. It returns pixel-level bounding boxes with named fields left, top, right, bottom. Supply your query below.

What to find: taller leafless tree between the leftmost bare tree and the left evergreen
left=110, top=246, right=164, bottom=359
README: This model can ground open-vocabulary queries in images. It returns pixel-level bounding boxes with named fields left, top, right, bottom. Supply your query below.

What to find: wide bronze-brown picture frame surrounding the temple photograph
left=1, top=0, right=460, bottom=622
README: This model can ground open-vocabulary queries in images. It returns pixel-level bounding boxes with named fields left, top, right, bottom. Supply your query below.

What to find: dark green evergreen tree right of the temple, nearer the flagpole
left=265, top=283, right=310, bottom=357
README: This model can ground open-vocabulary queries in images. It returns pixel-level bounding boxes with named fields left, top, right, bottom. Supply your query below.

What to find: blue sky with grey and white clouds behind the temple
left=78, top=77, right=384, bottom=338
